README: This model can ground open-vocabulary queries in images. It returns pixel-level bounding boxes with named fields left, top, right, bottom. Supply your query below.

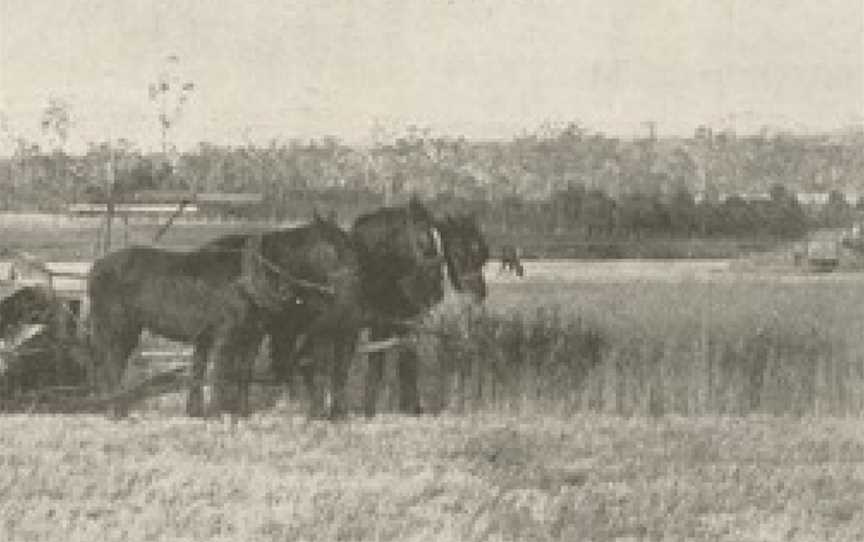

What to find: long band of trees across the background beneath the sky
left=0, top=124, right=864, bottom=241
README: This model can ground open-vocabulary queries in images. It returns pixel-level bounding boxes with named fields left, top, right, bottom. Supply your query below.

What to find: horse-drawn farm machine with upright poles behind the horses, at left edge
left=0, top=193, right=204, bottom=412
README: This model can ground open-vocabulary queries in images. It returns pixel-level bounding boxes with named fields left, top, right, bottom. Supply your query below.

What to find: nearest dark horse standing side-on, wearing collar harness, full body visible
left=88, top=217, right=361, bottom=415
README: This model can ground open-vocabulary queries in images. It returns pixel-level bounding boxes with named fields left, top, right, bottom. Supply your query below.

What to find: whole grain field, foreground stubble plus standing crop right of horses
left=0, top=262, right=864, bottom=541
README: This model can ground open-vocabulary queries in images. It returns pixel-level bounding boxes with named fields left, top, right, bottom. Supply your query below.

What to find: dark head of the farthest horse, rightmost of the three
left=438, top=214, right=489, bottom=300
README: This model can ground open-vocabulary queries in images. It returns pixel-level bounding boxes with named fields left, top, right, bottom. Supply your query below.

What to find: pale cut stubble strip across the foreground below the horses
left=0, top=414, right=864, bottom=542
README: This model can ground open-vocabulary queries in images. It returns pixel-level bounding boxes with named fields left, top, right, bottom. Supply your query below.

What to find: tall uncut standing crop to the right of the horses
left=388, top=282, right=864, bottom=416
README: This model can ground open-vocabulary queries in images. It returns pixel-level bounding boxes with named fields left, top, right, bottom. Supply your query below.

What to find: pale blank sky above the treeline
left=0, top=0, right=864, bottom=153
